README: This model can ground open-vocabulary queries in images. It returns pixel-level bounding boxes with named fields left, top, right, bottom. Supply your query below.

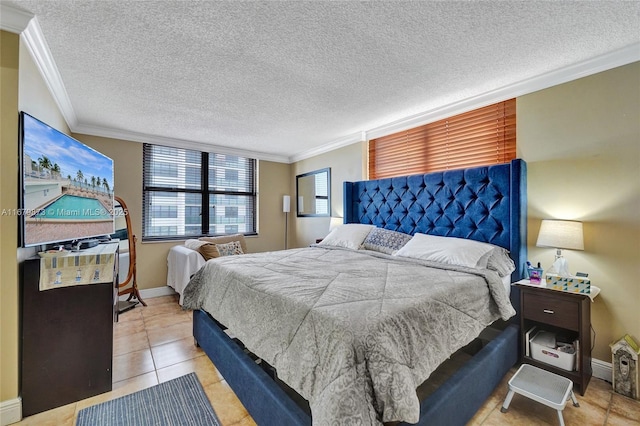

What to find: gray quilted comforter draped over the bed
left=183, top=247, right=515, bottom=425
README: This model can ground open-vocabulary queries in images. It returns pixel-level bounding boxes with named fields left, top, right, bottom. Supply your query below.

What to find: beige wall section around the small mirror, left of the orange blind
left=290, top=142, right=366, bottom=248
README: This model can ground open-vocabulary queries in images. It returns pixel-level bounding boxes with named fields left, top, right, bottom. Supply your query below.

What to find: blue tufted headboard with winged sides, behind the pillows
left=344, top=160, right=527, bottom=312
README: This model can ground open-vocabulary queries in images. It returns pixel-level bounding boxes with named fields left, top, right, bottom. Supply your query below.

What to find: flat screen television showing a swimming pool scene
left=18, top=112, right=114, bottom=247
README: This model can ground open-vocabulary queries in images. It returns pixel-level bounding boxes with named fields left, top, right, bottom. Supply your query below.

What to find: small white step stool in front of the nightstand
left=500, top=364, right=580, bottom=426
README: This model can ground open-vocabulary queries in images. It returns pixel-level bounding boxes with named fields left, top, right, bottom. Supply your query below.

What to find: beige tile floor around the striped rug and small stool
left=11, top=296, right=640, bottom=426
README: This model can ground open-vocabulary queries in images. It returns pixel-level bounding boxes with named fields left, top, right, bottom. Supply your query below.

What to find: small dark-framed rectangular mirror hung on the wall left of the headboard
left=296, top=167, right=331, bottom=217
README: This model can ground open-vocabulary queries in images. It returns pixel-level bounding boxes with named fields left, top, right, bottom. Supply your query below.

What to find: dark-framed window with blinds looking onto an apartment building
left=142, top=144, right=257, bottom=241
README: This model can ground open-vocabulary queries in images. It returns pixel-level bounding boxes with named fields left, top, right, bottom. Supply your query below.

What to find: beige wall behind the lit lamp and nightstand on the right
left=517, top=62, right=640, bottom=362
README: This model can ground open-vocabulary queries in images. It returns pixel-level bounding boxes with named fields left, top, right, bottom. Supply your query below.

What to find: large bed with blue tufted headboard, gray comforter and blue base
left=185, top=160, right=526, bottom=424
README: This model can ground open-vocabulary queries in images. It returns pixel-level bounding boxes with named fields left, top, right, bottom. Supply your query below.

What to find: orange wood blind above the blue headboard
left=369, top=99, right=516, bottom=179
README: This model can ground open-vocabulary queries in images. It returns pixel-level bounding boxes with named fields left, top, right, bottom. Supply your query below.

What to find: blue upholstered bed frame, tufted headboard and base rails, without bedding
left=193, top=160, right=527, bottom=426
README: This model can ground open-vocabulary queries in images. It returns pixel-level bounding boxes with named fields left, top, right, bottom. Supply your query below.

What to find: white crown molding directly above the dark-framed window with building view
left=71, top=124, right=289, bottom=163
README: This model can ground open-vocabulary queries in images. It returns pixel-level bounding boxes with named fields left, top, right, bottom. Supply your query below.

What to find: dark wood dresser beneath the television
left=20, top=246, right=118, bottom=417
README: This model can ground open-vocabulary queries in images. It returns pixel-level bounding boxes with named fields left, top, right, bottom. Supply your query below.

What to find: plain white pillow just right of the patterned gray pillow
left=395, top=233, right=496, bottom=268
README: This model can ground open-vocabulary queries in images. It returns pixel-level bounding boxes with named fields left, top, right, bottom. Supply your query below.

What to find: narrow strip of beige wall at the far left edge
left=0, top=31, right=20, bottom=401
